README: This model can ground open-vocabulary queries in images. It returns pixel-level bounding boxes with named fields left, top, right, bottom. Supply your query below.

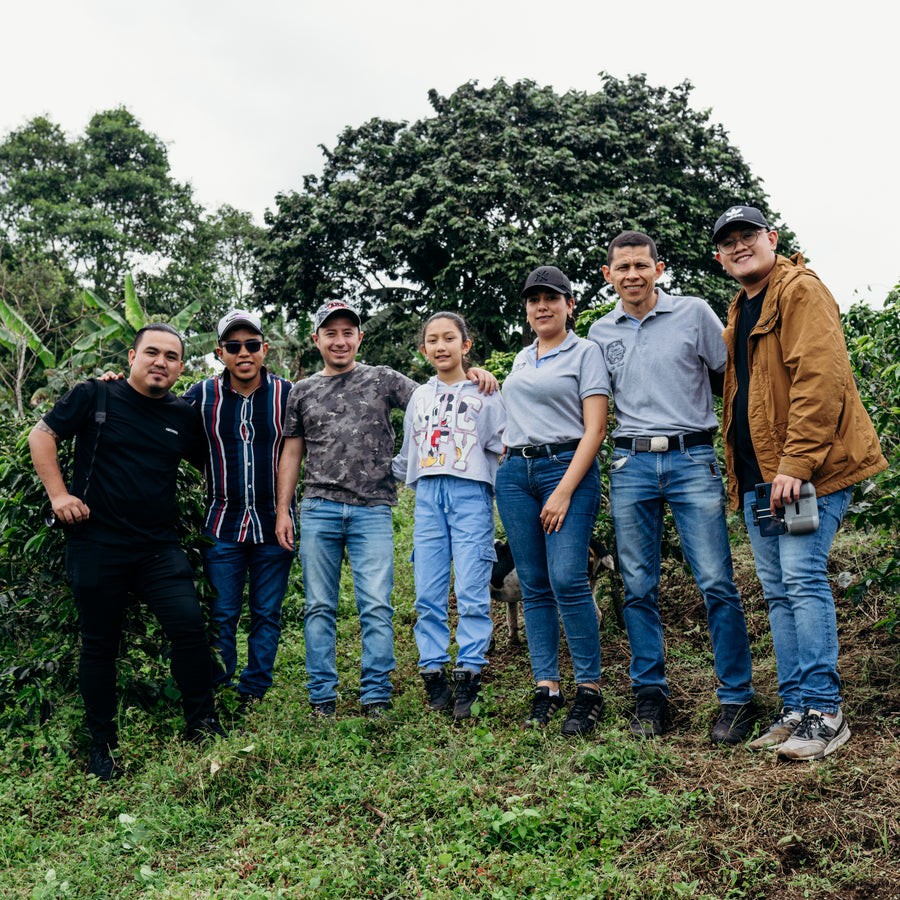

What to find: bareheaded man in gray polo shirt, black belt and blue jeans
left=588, top=231, right=753, bottom=744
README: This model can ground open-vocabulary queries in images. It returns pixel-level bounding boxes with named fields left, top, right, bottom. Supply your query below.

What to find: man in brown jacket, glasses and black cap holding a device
left=713, top=206, right=887, bottom=760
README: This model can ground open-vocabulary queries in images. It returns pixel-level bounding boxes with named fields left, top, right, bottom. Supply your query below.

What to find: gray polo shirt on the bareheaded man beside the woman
left=588, top=289, right=726, bottom=438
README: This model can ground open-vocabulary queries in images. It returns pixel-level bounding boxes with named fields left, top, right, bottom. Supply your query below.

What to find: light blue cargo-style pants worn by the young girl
left=413, top=475, right=497, bottom=672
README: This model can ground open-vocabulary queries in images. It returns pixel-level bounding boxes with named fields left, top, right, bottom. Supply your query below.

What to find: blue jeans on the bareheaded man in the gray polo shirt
left=609, top=445, right=753, bottom=703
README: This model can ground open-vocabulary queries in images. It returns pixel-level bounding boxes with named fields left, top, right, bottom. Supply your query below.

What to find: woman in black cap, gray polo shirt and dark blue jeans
left=496, top=266, right=610, bottom=735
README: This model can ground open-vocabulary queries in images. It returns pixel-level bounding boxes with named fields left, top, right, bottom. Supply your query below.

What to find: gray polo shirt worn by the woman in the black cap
left=503, top=331, right=609, bottom=447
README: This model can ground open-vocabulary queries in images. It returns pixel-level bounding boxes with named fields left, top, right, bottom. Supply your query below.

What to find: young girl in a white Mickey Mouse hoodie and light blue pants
left=394, top=312, right=506, bottom=720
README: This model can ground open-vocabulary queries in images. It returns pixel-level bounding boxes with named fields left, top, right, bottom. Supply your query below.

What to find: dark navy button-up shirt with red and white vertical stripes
left=184, top=367, right=291, bottom=544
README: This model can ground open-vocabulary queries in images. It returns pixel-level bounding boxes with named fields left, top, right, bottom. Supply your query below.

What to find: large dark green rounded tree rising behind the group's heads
left=256, top=74, right=793, bottom=358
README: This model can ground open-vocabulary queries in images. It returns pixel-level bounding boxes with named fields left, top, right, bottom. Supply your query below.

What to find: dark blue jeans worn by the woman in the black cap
left=496, top=451, right=600, bottom=684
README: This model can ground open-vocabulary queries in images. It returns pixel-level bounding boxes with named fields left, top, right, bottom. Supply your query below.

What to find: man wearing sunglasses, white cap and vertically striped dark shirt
left=184, top=309, right=294, bottom=712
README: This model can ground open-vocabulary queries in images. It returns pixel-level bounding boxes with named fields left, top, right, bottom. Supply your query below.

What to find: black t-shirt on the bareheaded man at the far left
left=44, top=380, right=204, bottom=546
